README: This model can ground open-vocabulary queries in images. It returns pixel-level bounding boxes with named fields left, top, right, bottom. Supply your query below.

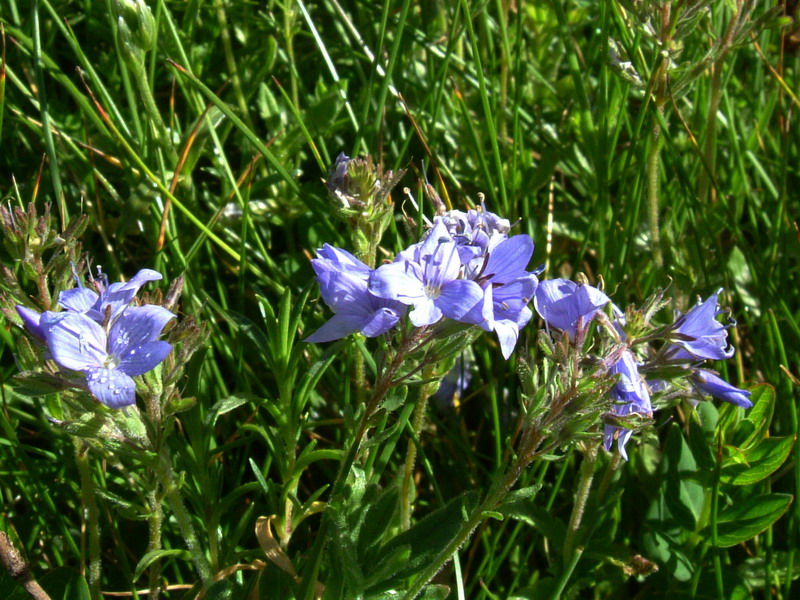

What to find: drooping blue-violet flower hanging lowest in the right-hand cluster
left=603, top=350, right=653, bottom=460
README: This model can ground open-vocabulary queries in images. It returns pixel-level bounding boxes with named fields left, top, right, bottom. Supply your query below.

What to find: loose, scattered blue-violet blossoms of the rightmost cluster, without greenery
left=534, top=279, right=752, bottom=459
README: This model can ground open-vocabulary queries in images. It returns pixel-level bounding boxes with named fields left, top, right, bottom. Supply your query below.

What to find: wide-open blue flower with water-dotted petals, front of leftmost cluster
left=40, top=305, right=175, bottom=408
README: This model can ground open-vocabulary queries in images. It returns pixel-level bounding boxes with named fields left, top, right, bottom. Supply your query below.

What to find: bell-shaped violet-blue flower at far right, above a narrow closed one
left=667, top=290, right=733, bottom=360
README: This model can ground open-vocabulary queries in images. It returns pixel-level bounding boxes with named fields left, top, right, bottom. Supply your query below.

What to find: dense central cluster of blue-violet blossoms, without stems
left=306, top=206, right=539, bottom=358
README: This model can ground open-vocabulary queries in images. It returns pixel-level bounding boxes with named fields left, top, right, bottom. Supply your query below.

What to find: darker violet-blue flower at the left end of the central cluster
left=305, top=244, right=406, bottom=342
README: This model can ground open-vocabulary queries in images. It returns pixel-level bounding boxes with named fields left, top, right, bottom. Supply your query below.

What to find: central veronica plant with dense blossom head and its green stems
left=306, top=198, right=552, bottom=593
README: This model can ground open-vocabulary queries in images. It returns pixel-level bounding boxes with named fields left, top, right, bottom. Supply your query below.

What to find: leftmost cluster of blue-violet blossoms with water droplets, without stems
left=17, top=269, right=175, bottom=408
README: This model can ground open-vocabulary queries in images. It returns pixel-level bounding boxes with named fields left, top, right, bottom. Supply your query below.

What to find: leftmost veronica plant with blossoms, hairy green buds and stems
left=0, top=206, right=211, bottom=598
